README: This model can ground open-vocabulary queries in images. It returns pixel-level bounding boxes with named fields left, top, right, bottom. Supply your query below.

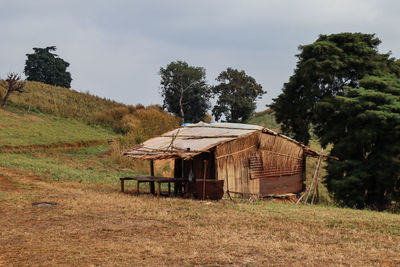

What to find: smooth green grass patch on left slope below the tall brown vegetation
left=0, top=107, right=115, bottom=148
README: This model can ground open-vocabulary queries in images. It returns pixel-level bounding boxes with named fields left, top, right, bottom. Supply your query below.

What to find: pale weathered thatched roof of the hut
left=123, top=122, right=324, bottom=159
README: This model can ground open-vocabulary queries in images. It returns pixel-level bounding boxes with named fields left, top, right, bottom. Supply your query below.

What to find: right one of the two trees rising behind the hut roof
left=212, top=68, right=266, bottom=122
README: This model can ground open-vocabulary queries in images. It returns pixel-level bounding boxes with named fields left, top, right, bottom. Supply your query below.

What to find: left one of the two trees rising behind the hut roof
left=160, top=61, right=210, bottom=122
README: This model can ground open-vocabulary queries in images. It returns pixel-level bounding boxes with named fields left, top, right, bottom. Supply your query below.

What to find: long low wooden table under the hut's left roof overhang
left=120, top=176, right=189, bottom=197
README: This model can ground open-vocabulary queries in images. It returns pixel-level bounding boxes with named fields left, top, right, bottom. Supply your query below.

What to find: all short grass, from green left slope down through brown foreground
left=0, top=104, right=400, bottom=266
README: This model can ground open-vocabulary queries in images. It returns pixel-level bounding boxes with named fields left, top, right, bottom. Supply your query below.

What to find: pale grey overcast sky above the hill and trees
left=0, top=0, right=400, bottom=110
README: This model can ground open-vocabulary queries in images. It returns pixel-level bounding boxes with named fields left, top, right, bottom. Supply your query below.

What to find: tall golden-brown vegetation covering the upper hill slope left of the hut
left=0, top=81, right=179, bottom=145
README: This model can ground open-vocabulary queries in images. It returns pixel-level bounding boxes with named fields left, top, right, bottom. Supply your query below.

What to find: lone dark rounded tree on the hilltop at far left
left=24, top=46, right=72, bottom=88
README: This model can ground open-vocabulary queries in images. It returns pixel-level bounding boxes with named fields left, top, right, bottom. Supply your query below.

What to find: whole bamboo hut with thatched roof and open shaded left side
left=123, top=122, right=318, bottom=200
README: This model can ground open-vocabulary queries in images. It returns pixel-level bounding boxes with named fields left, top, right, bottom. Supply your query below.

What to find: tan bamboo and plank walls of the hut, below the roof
left=215, top=132, right=305, bottom=197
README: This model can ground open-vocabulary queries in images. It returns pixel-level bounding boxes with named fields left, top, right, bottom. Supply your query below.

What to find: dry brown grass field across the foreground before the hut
left=0, top=169, right=400, bottom=266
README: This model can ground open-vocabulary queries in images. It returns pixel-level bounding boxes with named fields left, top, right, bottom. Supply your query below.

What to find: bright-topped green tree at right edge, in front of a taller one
left=315, top=75, right=400, bottom=210
